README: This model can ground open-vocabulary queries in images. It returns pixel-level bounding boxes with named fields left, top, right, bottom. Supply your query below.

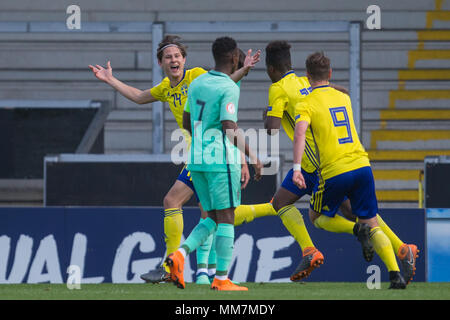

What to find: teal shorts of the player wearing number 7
left=191, top=171, right=241, bottom=211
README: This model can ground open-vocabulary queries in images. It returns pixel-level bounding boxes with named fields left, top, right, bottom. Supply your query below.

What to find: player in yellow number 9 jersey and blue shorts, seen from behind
left=292, top=52, right=416, bottom=289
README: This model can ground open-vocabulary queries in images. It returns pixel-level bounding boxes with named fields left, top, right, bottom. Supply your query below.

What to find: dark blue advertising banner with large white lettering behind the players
left=0, top=207, right=425, bottom=283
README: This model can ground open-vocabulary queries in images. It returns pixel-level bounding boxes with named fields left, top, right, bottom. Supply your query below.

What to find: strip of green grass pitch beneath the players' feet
left=0, top=282, right=450, bottom=300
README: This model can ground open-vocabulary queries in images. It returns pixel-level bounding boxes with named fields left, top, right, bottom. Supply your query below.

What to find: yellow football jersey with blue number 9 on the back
left=295, top=85, right=370, bottom=180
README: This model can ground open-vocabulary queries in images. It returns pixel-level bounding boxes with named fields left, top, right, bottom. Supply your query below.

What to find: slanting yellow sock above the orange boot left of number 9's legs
left=278, top=205, right=314, bottom=251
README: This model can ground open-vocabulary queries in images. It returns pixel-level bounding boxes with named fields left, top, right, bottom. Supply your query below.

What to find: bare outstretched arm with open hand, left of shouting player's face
left=89, top=61, right=157, bottom=104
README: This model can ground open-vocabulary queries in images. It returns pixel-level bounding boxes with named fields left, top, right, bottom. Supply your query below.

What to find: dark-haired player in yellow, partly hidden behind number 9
left=235, top=41, right=353, bottom=281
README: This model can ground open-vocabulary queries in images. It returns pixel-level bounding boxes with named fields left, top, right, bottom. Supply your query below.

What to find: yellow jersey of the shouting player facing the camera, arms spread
left=150, top=68, right=207, bottom=128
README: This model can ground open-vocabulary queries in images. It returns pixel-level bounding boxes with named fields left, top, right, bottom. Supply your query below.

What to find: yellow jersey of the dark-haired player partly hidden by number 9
left=267, top=71, right=319, bottom=173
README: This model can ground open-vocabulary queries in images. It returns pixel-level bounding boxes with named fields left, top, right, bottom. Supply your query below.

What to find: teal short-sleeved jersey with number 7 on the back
left=184, top=70, right=241, bottom=172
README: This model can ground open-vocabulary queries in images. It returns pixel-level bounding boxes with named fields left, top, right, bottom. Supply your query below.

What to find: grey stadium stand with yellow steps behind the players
left=0, top=0, right=450, bottom=207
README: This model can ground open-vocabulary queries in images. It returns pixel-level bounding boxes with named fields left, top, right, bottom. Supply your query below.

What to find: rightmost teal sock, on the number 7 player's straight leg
left=216, top=223, right=234, bottom=280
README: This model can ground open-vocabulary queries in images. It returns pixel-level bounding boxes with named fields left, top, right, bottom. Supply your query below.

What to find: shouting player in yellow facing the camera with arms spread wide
left=89, top=35, right=260, bottom=282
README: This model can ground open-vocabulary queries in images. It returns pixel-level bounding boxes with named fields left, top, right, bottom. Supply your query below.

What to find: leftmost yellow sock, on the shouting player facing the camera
left=164, top=208, right=183, bottom=272
